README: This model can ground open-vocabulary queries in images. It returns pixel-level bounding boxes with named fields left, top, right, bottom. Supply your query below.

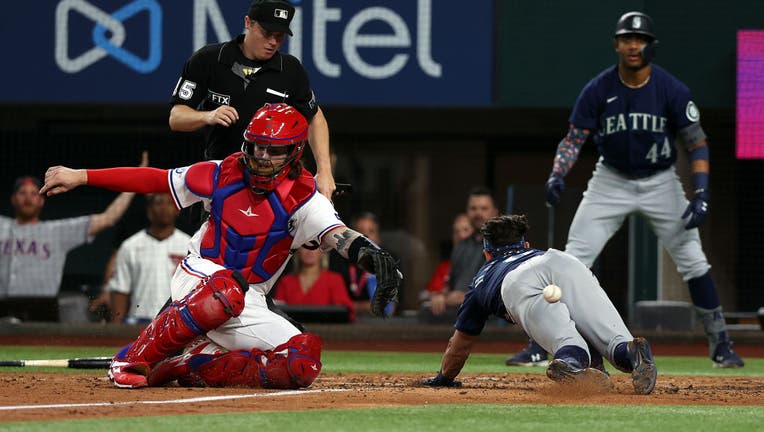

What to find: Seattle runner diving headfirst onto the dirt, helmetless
left=422, top=215, right=658, bottom=394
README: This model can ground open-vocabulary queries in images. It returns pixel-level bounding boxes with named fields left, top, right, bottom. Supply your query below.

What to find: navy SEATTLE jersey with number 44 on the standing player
left=570, top=64, right=700, bottom=177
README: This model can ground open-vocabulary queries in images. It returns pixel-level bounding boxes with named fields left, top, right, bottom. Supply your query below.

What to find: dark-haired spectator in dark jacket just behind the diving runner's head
left=430, top=187, right=499, bottom=316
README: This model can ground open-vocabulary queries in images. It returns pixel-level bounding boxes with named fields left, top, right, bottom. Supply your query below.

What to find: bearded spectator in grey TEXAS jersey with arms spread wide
left=0, top=152, right=148, bottom=321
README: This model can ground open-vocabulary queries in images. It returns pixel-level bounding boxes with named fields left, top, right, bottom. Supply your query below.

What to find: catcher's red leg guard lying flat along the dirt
left=188, top=333, right=321, bottom=389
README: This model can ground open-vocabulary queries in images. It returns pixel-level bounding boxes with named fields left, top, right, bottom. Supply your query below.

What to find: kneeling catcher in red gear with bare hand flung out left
left=42, top=104, right=402, bottom=388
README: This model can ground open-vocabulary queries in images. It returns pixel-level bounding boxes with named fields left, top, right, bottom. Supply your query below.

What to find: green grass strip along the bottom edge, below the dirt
left=0, top=405, right=764, bottom=432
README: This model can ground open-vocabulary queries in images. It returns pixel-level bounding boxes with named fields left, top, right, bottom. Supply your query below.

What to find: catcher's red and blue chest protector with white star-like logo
left=201, top=155, right=316, bottom=284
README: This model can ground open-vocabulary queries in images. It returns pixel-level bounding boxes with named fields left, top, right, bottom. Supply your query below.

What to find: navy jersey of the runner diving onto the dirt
left=454, top=249, right=544, bottom=336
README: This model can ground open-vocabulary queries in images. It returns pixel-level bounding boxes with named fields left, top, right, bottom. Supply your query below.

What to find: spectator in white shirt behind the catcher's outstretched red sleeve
left=108, top=194, right=191, bottom=324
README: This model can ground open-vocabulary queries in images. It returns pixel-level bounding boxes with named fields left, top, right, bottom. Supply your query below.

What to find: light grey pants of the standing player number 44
left=565, top=159, right=711, bottom=281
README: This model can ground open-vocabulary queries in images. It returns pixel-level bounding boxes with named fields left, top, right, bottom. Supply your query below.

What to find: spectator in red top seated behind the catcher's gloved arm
left=273, top=247, right=355, bottom=322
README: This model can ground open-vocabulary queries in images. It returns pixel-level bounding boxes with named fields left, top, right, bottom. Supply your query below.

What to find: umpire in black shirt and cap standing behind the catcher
left=169, top=0, right=335, bottom=199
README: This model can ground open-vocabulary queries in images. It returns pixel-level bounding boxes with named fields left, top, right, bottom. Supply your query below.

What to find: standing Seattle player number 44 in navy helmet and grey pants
left=524, top=12, right=743, bottom=367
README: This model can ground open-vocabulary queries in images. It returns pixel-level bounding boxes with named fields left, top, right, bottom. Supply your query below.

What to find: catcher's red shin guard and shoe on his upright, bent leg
left=109, top=270, right=249, bottom=388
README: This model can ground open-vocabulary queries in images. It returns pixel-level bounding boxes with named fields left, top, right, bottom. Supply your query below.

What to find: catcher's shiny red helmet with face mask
left=241, top=103, right=308, bottom=193
